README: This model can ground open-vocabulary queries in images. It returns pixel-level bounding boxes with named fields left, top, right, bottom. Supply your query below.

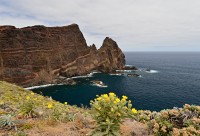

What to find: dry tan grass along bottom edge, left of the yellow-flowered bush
left=0, top=114, right=95, bottom=136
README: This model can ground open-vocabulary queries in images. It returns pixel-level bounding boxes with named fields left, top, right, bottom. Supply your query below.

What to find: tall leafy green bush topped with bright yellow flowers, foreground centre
left=90, top=93, right=137, bottom=136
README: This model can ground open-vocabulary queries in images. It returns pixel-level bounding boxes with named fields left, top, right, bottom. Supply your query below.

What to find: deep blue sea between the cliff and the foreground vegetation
left=33, top=52, right=200, bottom=111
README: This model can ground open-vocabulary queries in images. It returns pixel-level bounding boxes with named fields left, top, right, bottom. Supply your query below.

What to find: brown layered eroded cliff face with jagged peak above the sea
left=0, top=24, right=125, bottom=86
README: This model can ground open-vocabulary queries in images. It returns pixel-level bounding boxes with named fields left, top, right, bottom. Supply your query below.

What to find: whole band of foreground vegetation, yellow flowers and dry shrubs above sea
left=0, top=81, right=200, bottom=136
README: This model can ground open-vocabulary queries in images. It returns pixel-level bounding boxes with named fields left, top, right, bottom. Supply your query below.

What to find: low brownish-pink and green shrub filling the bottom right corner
left=148, top=104, right=200, bottom=136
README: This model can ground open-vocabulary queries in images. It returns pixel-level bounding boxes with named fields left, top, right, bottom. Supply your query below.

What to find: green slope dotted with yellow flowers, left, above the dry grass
left=0, top=81, right=83, bottom=135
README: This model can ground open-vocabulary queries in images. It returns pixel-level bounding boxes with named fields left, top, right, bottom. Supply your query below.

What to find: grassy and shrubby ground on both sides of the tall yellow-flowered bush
left=0, top=81, right=200, bottom=136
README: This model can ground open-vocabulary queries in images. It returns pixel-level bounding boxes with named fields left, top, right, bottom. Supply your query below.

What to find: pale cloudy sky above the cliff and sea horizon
left=0, top=0, right=200, bottom=51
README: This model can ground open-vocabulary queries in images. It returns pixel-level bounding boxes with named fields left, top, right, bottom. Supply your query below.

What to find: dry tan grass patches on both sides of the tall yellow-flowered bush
left=0, top=117, right=149, bottom=136
